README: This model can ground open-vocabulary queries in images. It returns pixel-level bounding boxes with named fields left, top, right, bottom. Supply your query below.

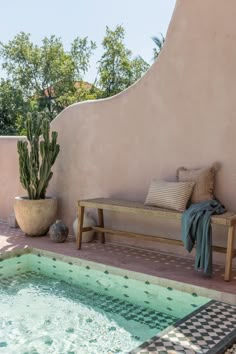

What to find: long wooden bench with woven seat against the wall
left=76, top=198, right=236, bottom=281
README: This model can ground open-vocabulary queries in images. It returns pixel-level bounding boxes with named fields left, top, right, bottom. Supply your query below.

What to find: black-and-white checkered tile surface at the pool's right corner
left=130, top=300, right=236, bottom=354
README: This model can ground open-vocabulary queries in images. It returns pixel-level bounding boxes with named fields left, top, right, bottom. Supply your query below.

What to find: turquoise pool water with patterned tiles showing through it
left=0, top=254, right=209, bottom=354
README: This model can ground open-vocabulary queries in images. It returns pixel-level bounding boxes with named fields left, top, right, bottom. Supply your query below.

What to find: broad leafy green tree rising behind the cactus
left=0, top=32, right=96, bottom=119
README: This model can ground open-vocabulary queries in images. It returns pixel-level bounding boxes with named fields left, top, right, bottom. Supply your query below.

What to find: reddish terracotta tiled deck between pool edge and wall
left=0, top=223, right=236, bottom=295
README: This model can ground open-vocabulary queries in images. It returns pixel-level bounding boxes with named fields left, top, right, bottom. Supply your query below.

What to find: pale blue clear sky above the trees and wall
left=0, top=0, right=175, bottom=82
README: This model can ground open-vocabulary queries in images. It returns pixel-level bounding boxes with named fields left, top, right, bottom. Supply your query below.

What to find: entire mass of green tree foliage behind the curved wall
left=0, top=26, right=149, bottom=135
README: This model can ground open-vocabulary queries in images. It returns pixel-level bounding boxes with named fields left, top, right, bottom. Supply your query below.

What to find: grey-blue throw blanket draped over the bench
left=182, top=199, right=226, bottom=276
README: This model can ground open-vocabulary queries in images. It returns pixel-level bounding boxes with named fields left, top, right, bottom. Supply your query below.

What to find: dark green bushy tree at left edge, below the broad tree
left=0, top=79, right=27, bottom=135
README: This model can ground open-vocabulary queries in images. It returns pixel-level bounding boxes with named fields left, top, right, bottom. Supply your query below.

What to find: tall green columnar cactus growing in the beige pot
left=17, top=113, right=60, bottom=199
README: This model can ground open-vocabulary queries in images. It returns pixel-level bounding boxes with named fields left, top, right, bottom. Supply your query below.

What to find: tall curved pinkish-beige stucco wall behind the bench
left=1, top=0, right=236, bottom=260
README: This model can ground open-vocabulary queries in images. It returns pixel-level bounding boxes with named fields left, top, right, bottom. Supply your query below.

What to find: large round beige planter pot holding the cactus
left=14, top=197, right=57, bottom=236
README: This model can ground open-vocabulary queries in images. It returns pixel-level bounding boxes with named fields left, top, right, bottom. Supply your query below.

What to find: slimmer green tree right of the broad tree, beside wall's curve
left=98, top=26, right=149, bottom=97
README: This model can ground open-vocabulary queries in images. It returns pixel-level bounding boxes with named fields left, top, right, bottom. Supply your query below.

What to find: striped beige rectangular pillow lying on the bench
left=145, top=179, right=195, bottom=211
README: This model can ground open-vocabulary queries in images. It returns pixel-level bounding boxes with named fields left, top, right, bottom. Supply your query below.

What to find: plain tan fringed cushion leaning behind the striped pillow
left=177, top=166, right=216, bottom=203
